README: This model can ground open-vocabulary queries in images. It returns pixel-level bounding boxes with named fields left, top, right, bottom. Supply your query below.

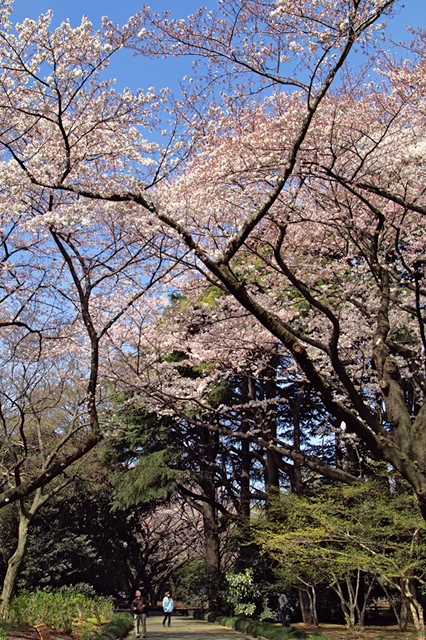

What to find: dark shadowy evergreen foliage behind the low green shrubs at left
left=17, top=476, right=145, bottom=595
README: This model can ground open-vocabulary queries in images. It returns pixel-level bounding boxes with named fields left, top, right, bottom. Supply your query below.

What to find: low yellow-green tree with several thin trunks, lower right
left=251, top=479, right=426, bottom=637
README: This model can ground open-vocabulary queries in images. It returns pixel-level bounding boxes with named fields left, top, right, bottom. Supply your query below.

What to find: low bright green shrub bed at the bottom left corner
left=9, top=587, right=114, bottom=633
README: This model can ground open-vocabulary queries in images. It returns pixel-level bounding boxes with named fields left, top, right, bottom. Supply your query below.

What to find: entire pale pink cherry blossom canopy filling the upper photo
left=0, top=0, right=426, bottom=524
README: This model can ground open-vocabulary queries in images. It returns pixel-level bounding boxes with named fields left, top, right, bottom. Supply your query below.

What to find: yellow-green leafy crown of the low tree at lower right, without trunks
left=260, top=482, right=426, bottom=580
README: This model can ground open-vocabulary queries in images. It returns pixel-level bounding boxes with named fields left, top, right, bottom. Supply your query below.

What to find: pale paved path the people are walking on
left=126, top=615, right=253, bottom=640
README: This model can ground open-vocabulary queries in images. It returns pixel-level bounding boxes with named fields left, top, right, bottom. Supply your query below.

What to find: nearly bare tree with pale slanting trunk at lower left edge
left=0, top=362, right=88, bottom=615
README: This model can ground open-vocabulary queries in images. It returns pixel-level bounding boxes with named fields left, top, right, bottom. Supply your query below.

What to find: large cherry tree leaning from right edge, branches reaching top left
left=0, top=0, right=426, bottom=524
